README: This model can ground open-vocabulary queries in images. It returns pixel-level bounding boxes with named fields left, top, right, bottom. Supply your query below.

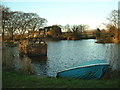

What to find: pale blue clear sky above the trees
left=2, top=0, right=119, bottom=29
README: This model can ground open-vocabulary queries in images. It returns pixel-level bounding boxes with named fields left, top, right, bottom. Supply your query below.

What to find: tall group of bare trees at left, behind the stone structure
left=0, top=5, right=47, bottom=39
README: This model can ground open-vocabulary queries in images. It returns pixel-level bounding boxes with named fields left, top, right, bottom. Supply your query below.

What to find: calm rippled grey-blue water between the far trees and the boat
left=3, top=39, right=120, bottom=77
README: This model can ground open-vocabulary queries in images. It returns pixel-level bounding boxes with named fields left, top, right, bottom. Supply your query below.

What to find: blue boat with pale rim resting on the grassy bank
left=57, top=60, right=109, bottom=79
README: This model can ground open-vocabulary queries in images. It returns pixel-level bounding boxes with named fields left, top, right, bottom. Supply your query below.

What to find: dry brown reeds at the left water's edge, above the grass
left=2, top=47, right=36, bottom=74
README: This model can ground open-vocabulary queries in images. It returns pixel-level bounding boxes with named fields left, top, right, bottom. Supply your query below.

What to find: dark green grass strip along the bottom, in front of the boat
left=2, top=71, right=120, bottom=88
